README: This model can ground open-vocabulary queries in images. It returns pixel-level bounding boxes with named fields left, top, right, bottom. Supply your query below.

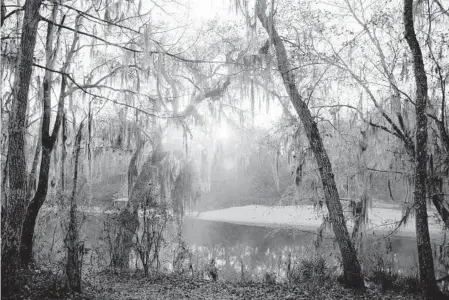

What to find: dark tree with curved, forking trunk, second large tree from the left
left=16, top=2, right=151, bottom=267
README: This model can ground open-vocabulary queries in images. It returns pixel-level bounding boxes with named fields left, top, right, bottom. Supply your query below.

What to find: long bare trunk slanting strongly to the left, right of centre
left=256, top=0, right=364, bottom=288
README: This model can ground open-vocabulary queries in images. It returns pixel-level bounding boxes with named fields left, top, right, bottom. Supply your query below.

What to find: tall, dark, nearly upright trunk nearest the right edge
left=404, top=0, right=439, bottom=297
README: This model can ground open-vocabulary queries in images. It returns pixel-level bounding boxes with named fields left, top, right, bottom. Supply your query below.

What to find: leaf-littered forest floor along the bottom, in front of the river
left=17, top=272, right=430, bottom=300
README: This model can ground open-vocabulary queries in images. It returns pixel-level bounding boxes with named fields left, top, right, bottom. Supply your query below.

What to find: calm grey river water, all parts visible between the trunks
left=36, top=204, right=449, bottom=280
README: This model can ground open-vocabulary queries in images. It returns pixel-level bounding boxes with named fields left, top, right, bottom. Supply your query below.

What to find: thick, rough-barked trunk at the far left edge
left=1, top=0, right=42, bottom=298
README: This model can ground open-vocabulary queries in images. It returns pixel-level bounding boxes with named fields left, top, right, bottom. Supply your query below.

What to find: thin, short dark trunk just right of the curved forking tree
left=65, top=122, right=84, bottom=293
